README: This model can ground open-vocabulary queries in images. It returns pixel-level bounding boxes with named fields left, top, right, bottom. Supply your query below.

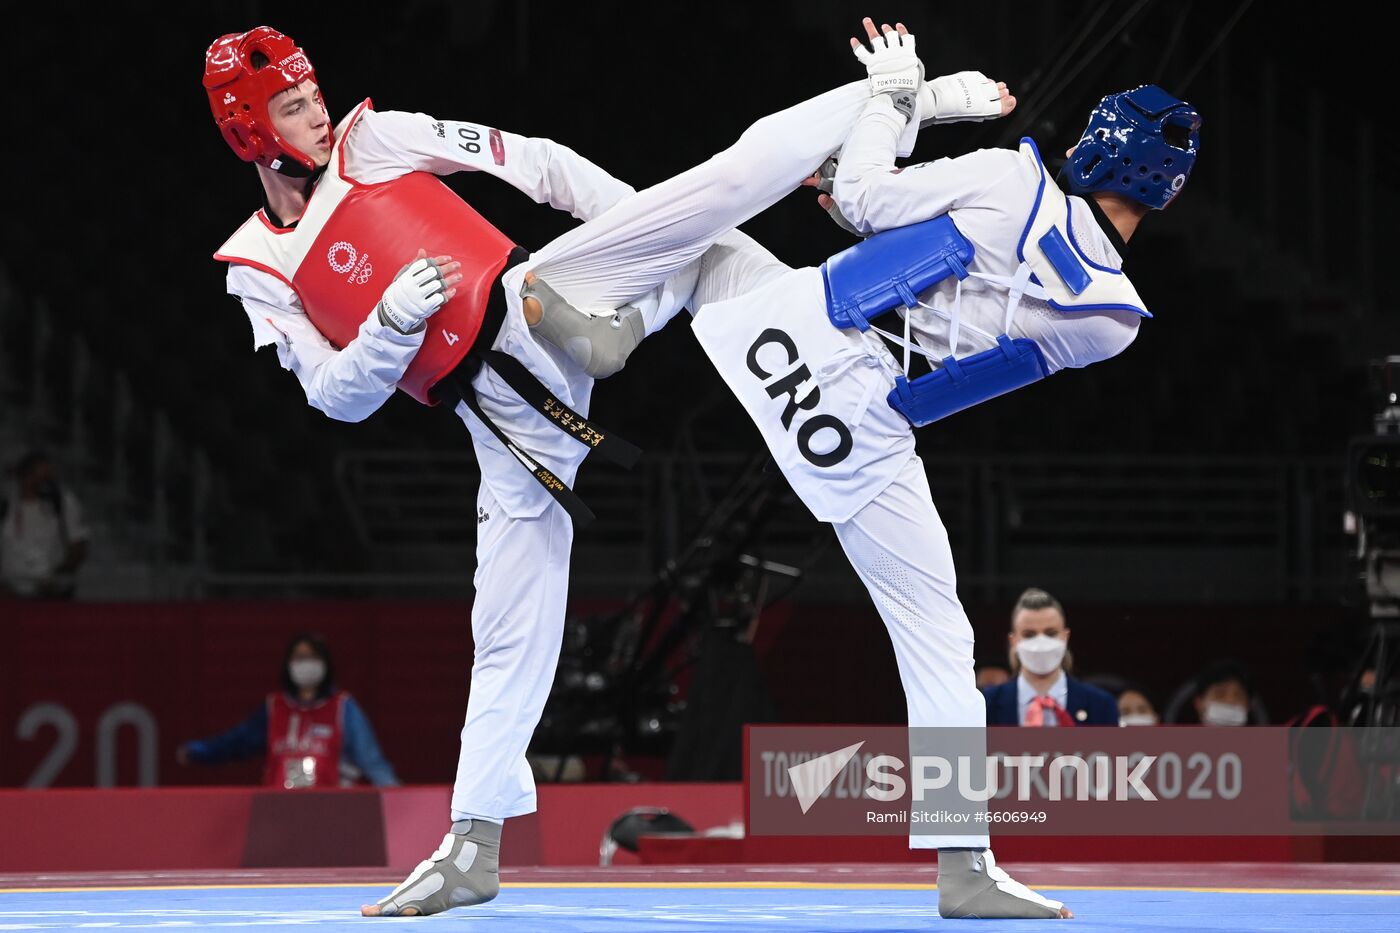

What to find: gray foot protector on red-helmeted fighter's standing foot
left=379, top=820, right=501, bottom=916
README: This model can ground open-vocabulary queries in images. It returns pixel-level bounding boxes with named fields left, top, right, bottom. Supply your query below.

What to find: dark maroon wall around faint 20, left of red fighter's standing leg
left=0, top=601, right=472, bottom=787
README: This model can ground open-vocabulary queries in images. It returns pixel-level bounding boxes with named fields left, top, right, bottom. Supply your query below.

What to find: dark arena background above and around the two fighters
left=0, top=0, right=1400, bottom=762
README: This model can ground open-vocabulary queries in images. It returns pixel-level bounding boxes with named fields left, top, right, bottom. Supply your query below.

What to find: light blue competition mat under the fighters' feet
left=0, top=885, right=1400, bottom=933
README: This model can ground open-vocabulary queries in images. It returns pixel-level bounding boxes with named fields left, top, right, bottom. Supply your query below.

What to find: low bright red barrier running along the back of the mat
left=0, top=783, right=1377, bottom=880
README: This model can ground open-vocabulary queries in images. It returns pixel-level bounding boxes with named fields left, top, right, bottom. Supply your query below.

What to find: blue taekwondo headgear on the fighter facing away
left=1064, top=84, right=1201, bottom=210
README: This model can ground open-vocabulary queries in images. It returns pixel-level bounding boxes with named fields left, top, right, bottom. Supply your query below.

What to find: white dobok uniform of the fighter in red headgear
left=218, top=81, right=913, bottom=821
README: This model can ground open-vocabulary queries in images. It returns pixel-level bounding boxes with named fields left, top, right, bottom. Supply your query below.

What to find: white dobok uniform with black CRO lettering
left=690, top=98, right=1138, bottom=849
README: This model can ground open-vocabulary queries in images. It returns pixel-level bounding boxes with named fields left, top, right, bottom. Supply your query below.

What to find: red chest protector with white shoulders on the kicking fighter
left=214, top=101, right=514, bottom=405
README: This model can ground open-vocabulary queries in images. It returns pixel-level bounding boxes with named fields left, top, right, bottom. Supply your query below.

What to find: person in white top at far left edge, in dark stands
left=0, top=450, right=88, bottom=600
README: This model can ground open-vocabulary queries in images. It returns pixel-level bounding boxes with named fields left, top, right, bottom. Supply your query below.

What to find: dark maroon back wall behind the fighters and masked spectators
left=0, top=601, right=1344, bottom=787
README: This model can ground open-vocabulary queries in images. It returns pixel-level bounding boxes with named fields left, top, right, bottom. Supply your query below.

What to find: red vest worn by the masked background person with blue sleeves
left=263, top=691, right=349, bottom=790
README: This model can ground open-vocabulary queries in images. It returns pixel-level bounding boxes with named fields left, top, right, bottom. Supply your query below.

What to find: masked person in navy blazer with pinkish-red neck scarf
left=981, top=588, right=1119, bottom=726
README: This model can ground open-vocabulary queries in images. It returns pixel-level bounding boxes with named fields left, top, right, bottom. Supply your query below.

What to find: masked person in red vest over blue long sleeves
left=175, top=635, right=399, bottom=790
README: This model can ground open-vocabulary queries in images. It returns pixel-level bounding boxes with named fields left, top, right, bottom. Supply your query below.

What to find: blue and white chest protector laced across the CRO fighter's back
left=822, top=139, right=1151, bottom=427
